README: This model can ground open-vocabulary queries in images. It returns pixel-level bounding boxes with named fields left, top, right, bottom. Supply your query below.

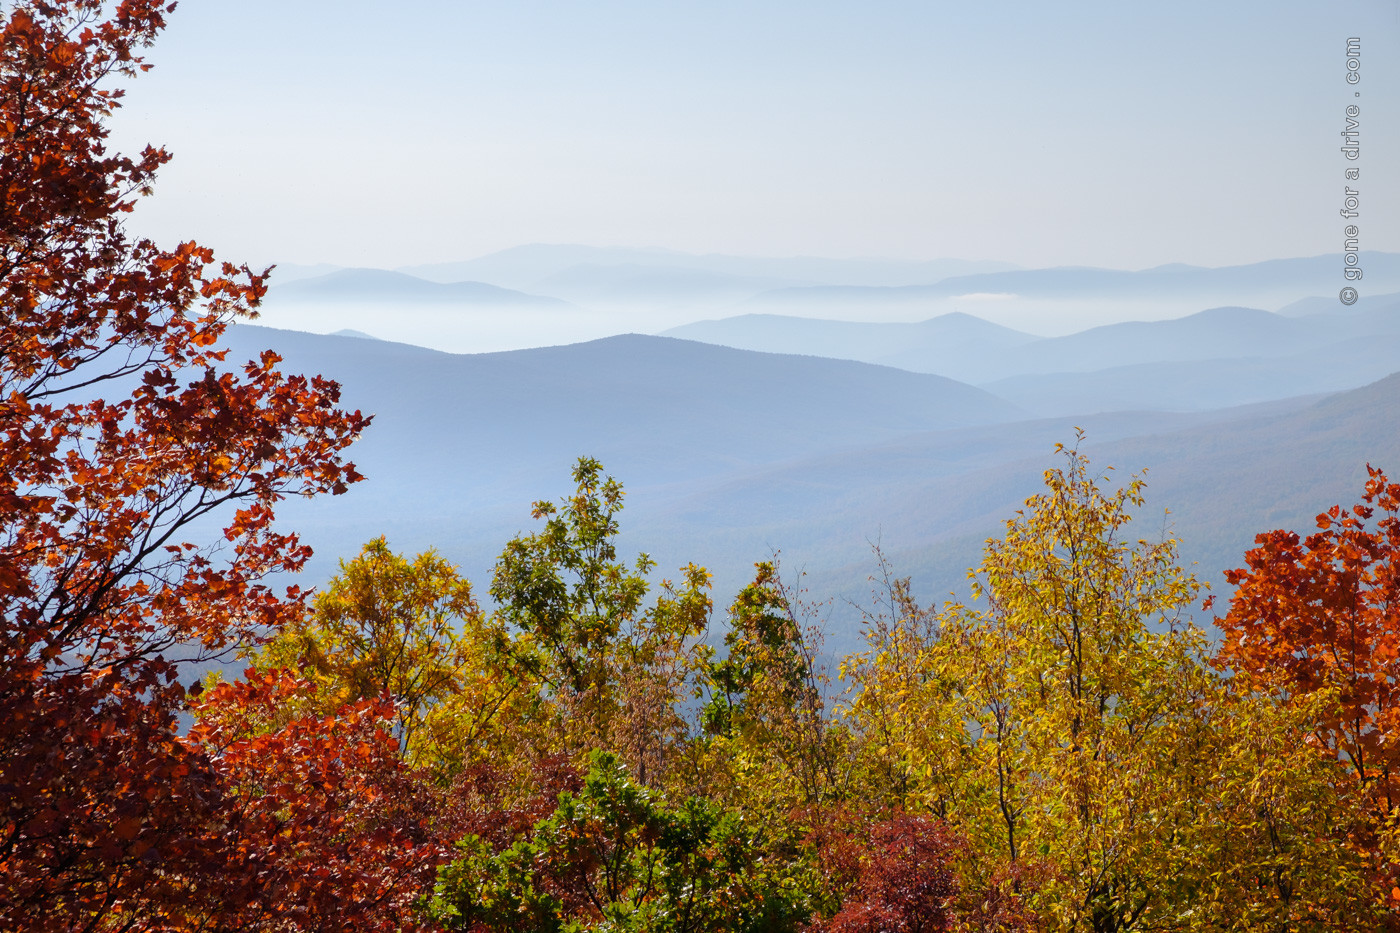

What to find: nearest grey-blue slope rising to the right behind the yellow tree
left=636, top=374, right=1400, bottom=650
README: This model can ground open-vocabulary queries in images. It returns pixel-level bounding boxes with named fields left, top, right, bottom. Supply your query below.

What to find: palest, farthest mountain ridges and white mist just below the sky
left=257, top=245, right=1400, bottom=348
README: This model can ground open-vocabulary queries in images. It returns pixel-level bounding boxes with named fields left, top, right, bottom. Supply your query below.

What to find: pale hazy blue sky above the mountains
left=113, top=0, right=1400, bottom=268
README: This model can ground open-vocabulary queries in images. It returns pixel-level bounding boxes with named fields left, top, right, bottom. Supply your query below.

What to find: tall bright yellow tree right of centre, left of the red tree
left=853, top=437, right=1210, bottom=933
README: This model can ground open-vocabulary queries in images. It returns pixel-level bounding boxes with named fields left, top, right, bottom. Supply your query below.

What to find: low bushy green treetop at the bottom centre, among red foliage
left=431, top=752, right=809, bottom=933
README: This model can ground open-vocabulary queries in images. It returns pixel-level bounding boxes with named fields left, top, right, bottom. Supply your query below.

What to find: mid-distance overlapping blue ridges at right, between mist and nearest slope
left=666, top=288, right=1400, bottom=415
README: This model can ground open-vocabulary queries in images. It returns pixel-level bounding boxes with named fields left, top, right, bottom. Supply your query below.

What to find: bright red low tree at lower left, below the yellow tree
left=183, top=670, right=458, bottom=933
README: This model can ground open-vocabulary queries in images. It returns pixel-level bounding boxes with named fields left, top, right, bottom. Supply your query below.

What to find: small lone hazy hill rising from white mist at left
left=267, top=269, right=564, bottom=308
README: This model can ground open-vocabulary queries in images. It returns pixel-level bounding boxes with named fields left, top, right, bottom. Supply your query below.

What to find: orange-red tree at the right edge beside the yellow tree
left=1217, top=465, right=1400, bottom=929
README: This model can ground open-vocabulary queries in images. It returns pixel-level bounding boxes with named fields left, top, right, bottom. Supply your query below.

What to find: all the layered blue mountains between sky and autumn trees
left=231, top=247, right=1400, bottom=650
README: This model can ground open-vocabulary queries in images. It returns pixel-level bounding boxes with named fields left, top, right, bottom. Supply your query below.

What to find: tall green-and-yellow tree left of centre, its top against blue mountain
left=491, top=457, right=711, bottom=785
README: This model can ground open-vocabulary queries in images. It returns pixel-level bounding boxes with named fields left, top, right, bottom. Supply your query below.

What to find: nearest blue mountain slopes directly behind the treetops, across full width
left=207, top=326, right=1400, bottom=647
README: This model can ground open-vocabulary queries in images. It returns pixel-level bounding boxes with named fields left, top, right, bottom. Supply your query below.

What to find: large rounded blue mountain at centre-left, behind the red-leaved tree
left=215, top=326, right=1022, bottom=613
